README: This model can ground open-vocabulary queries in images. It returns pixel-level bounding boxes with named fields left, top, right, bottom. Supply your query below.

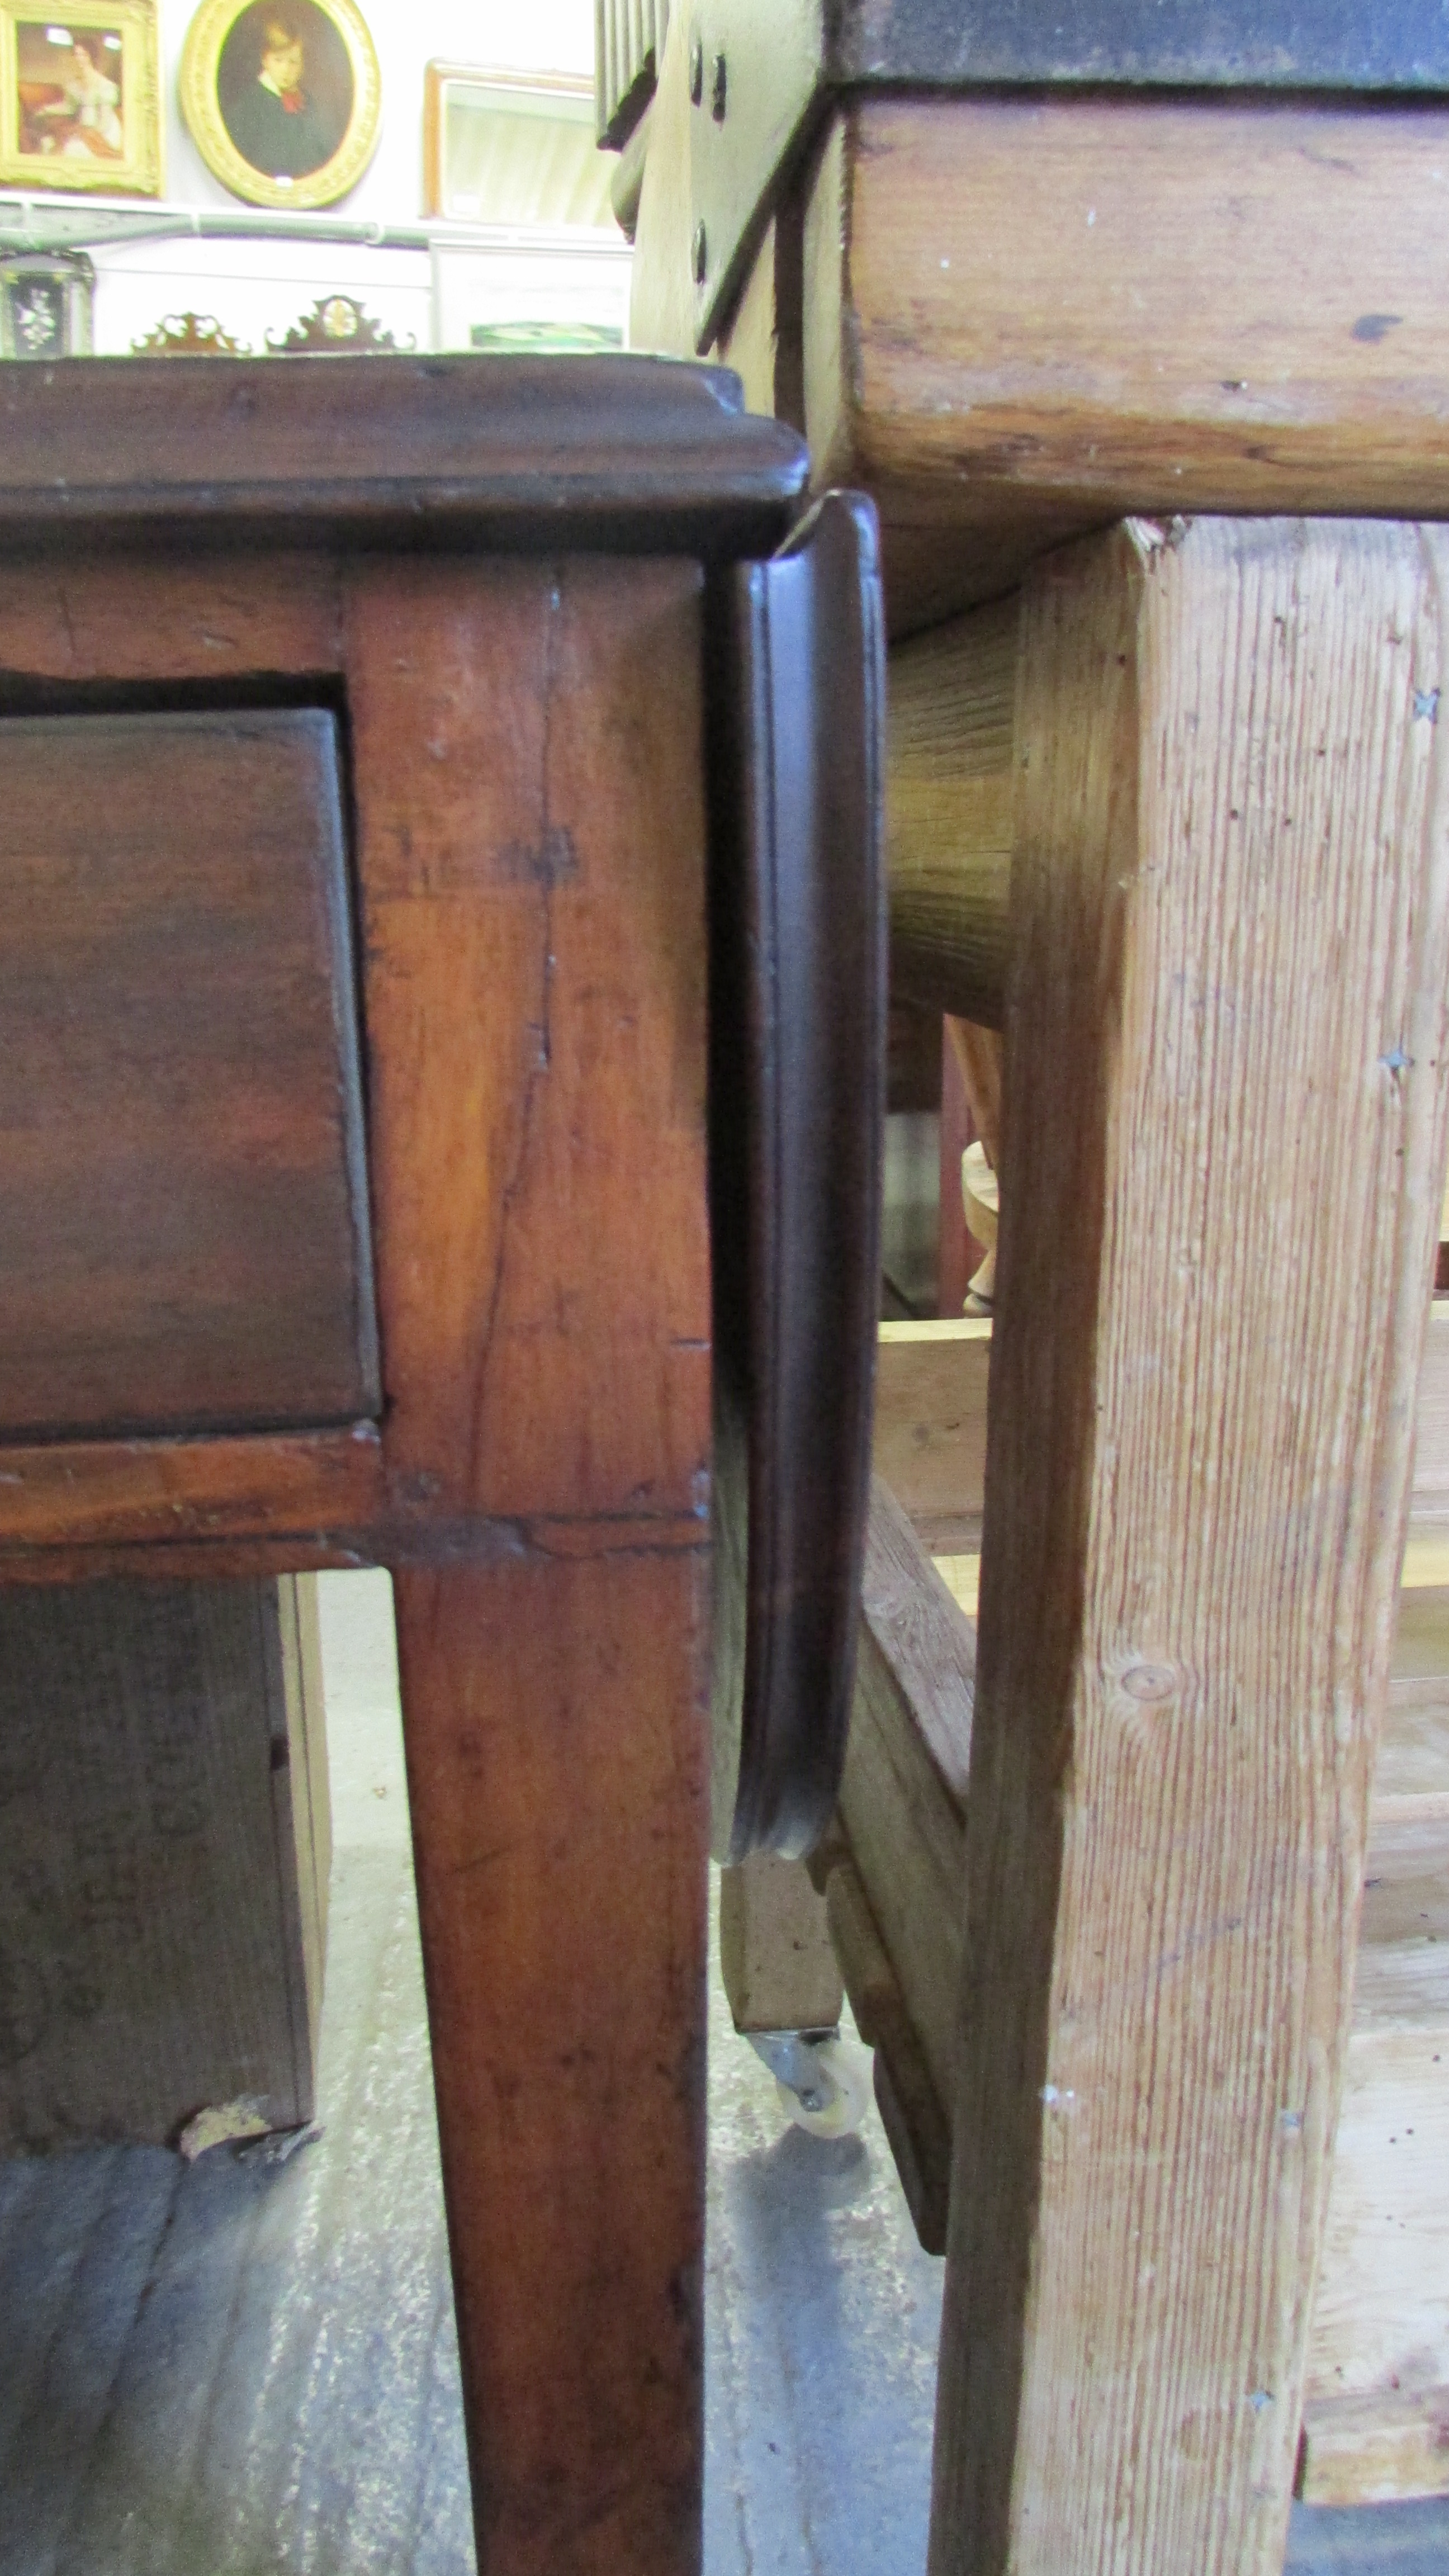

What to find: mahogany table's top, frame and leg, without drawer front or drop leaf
left=0, top=361, right=802, bottom=2576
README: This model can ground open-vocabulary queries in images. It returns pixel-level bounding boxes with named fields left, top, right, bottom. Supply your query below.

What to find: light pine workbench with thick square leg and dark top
left=634, top=20, right=1449, bottom=2576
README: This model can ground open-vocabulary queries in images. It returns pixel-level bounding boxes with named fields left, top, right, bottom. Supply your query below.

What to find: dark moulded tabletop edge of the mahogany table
left=0, top=358, right=804, bottom=559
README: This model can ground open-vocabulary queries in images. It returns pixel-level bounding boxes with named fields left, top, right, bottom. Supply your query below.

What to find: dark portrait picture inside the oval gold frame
left=216, top=0, right=353, bottom=181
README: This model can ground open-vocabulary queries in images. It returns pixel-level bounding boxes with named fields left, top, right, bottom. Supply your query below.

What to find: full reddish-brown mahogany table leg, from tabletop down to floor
left=348, top=556, right=709, bottom=2576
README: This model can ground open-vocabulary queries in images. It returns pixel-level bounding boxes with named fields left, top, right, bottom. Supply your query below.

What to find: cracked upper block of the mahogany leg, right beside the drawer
left=348, top=562, right=709, bottom=1517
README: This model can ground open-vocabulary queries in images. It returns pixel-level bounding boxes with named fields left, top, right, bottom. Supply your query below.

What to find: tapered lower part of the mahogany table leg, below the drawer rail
left=397, top=1554, right=709, bottom=2576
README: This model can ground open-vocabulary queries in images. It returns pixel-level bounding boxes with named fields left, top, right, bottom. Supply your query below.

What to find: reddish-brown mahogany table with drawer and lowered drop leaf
left=0, top=358, right=884, bottom=2576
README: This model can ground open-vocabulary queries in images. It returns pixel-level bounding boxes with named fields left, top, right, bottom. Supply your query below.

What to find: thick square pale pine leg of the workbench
left=931, top=520, right=1449, bottom=2576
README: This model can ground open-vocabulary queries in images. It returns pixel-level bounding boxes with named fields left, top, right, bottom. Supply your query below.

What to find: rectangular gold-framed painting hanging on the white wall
left=0, top=0, right=163, bottom=196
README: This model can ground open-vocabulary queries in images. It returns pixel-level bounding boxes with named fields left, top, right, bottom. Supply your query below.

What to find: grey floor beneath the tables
left=0, top=1576, right=1449, bottom=2576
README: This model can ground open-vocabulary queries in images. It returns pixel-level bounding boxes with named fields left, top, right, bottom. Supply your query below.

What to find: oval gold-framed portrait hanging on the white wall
left=178, top=0, right=382, bottom=206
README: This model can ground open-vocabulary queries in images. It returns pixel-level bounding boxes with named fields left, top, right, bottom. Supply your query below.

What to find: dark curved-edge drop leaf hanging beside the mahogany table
left=709, top=495, right=887, bottom=1863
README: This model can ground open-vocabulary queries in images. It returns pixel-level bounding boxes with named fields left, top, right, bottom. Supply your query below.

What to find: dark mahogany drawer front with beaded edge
left=0, top=711, right=379, bottom=1437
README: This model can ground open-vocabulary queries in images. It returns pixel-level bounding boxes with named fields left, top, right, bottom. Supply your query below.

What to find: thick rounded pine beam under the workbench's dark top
left=804, top=95, right=1449, bottom=631
